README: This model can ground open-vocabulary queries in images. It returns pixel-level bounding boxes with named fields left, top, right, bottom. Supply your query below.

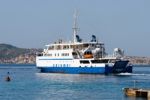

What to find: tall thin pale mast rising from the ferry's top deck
left=72, top=9, right=79, bottom=43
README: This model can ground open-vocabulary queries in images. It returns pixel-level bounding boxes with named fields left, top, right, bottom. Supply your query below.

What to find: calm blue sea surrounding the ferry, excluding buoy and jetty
left=0, top=65, right=150, bottom=100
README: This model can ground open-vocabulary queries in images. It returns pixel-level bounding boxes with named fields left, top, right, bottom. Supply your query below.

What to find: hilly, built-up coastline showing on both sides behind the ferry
left=0, top=44, right=150, bottom=65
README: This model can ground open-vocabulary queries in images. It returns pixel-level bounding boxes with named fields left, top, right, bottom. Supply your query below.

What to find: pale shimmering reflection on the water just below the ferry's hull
left=36, top=73, right=107, bottom=82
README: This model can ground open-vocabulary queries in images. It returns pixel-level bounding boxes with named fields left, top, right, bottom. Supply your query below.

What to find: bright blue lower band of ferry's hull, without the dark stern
left=39, top=67, right=107, bottom=74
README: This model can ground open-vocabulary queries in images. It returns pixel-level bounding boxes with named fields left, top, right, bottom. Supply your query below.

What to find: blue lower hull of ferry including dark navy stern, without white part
left=38, top=66, right=132, bottom=74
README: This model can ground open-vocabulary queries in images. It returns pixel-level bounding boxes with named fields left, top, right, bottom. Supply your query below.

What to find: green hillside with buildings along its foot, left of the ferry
left=0, top=44, right=41, bottom=64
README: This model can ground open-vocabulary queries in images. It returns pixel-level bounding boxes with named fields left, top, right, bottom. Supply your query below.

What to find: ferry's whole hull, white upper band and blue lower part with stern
left=36, top=57, right=132, bottom=74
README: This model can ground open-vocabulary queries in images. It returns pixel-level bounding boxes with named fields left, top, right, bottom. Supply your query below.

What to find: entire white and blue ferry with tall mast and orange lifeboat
left=36, top=11, right=132, bottom=74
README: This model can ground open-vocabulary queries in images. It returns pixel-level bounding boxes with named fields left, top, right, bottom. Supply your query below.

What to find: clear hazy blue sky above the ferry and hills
left=0, top=0, right=150, bottom=57
